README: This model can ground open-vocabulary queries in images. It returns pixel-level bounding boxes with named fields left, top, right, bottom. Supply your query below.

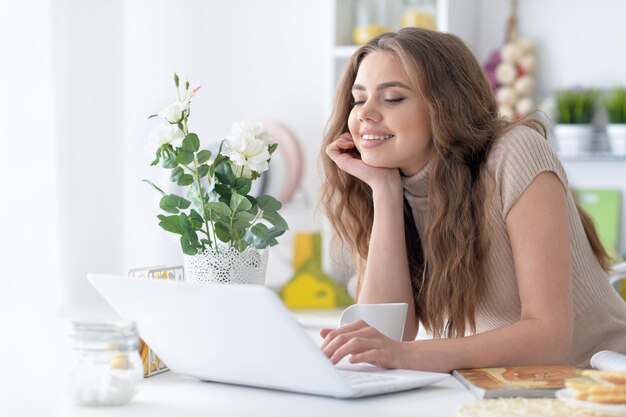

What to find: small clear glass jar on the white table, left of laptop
left=67, top=321, right=143, bottom=406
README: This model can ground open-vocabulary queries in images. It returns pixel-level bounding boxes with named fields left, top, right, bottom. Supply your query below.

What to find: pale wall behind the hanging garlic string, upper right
left=476, top=0, right=626, bottom=94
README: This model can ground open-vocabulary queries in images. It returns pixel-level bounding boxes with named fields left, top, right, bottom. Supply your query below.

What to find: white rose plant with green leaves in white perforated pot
left=144, top=74, right=288, bottom=283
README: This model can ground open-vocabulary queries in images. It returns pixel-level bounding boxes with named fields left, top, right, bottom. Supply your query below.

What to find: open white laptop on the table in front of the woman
left=88, top=274, right=450, bottom=398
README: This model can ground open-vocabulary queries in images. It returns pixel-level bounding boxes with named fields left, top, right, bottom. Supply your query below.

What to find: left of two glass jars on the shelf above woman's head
left=352, top=0, right=390, bottom=45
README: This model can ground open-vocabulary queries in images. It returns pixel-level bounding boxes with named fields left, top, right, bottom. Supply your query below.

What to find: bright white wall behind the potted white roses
left=55, top=0, right=330, bottom=316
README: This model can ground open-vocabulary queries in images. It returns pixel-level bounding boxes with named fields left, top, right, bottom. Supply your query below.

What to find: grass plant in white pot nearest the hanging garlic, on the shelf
left=554, top=89, right=597, bottom=155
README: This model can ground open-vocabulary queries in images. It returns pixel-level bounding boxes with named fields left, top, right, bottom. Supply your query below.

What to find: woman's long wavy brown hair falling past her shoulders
left=320, top=28, right=609, bottom=337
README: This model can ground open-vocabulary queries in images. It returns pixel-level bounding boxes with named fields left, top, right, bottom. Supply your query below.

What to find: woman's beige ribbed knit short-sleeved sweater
left=403, top=127, right=626, bottom=367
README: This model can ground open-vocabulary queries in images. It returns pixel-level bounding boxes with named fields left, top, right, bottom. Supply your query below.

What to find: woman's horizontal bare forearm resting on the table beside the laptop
left=401, top=319, right=571, bottom=372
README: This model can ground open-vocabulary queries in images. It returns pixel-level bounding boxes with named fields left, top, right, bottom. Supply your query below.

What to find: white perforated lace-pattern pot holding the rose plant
left=183, top=246, right=269, bottom=285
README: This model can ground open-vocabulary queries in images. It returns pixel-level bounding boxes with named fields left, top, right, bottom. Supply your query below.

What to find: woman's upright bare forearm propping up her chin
left=359, top=177, right=418, bottom=340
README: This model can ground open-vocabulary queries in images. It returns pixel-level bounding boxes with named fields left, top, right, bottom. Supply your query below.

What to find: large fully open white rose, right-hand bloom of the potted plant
left=224, top=122, right=270, bottom=177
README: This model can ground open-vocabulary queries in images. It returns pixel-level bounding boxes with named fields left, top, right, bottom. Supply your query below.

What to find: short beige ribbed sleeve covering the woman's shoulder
left=487, top=126, right=568, bottom=218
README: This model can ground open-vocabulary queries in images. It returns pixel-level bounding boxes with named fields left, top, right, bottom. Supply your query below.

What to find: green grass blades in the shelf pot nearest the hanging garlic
left=554, top=89, right=598, bottom=124
